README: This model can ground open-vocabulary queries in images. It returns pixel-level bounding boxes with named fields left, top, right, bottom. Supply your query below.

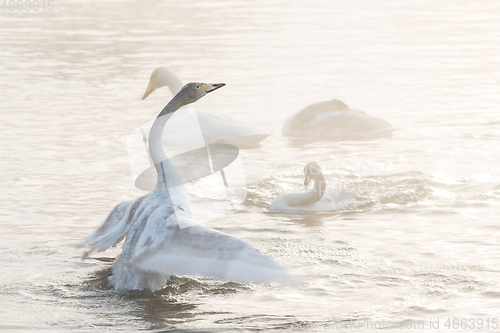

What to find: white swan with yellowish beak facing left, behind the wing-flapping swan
left=142, top=67, right=273, bottom=149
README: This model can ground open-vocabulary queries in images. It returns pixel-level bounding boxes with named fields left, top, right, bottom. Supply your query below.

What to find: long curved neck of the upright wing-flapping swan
left=149, top=94, right=189, bottom=191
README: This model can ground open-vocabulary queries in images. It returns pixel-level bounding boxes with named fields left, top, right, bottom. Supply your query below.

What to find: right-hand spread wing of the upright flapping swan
left=132, top=209, right=291, bottom=283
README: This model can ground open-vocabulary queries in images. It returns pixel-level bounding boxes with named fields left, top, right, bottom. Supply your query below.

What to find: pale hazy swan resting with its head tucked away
left=283, top=99, right=396, bottom=141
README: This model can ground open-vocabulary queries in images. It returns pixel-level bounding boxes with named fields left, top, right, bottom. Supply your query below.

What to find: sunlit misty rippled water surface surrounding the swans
left=0, top=0, right=500, bottom=332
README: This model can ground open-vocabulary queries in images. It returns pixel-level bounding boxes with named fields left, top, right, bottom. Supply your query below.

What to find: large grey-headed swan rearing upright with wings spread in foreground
left=81, top=83, right=289, bottom=291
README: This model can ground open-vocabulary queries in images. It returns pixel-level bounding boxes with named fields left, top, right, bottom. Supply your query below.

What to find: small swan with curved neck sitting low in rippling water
left=271, top=162, right=354, bottom=212
